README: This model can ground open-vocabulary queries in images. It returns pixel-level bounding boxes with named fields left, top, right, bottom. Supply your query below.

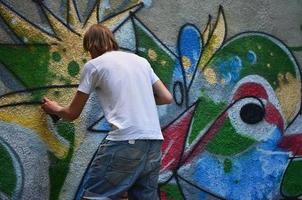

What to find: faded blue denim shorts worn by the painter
left=82, top=140, right=162, bottom=200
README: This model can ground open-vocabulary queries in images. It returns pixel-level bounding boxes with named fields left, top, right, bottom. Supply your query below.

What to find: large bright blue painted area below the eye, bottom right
left=183, top=128, right=289, bottom=199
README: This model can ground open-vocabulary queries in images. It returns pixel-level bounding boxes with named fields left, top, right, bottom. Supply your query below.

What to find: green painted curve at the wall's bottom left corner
left=0, top=144, right=17, bottom=197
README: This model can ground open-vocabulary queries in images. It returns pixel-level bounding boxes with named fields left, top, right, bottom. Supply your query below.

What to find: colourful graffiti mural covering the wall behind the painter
left=0, top=0, right=302, bottom=200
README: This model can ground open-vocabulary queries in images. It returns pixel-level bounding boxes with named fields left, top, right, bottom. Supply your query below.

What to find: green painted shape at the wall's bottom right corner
left=281, top=160, right=302, bottom=197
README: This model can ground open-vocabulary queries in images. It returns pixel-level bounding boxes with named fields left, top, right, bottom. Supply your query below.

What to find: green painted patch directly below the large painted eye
left=206, top=119, right=256, bottom=156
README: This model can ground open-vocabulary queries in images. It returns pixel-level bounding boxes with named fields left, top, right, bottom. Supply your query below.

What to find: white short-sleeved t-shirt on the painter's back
left=78, top=51, right=163, bottom=141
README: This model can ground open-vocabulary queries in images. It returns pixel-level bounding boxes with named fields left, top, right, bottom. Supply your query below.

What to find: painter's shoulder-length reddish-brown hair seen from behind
left=83, top=24, right=119, bottom=56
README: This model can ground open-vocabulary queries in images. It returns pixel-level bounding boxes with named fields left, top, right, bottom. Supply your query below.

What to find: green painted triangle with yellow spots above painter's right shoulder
left=134, top=25, right=176, bottom=86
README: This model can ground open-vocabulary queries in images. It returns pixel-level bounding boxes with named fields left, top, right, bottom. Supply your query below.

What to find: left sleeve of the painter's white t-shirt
left=78, top=62, right=98, bottom=94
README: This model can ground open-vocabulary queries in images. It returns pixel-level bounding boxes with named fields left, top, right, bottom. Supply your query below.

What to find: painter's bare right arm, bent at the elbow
left=152, top=80, right=173, bottom=105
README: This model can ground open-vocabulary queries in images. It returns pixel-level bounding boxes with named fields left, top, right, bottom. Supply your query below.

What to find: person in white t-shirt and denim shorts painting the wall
left=42, top=25, right=172, bottom=200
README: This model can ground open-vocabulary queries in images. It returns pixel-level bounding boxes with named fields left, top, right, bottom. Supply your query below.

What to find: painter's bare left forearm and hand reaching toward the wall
left=41, top=91, right=89, bottom=121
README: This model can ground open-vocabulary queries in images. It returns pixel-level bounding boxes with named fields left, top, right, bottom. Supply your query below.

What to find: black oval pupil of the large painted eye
left=240, top=103, right=265, bottom=124
